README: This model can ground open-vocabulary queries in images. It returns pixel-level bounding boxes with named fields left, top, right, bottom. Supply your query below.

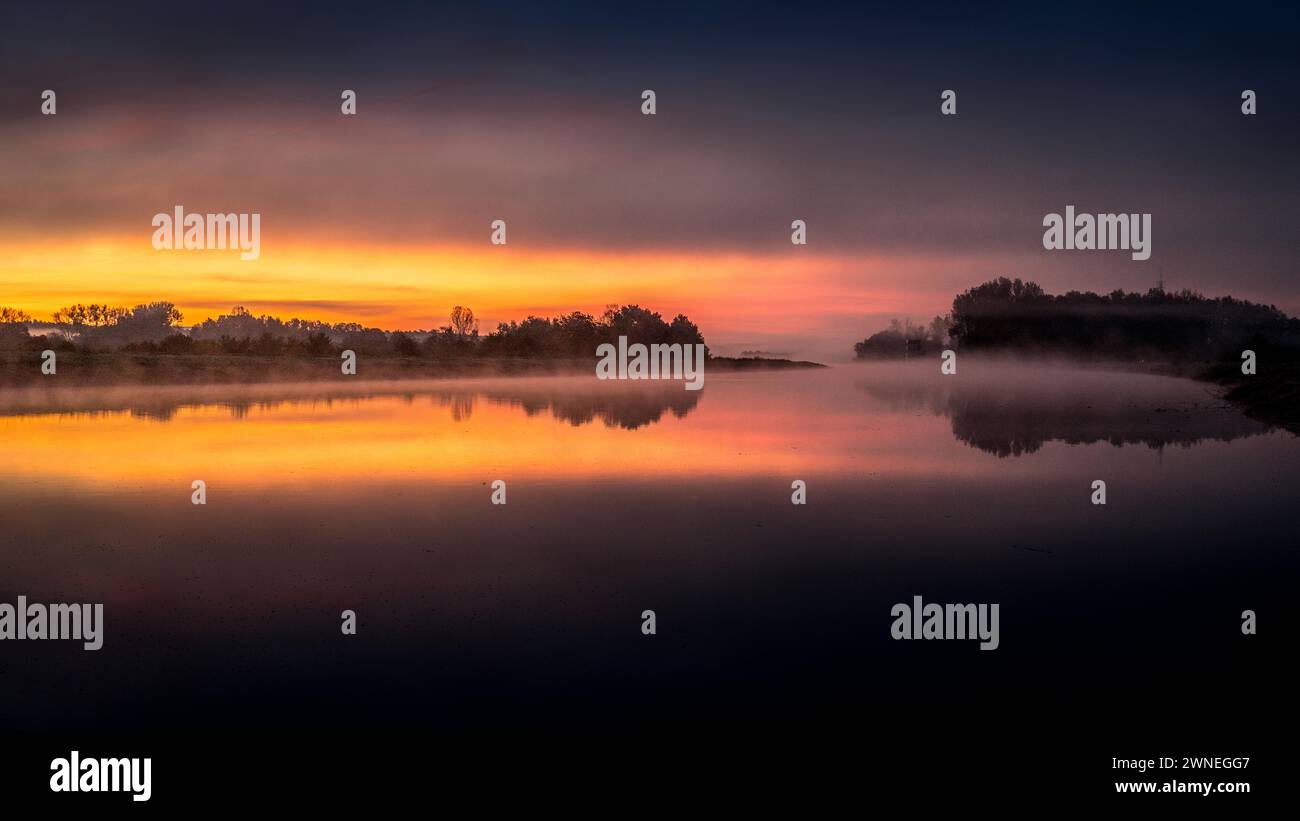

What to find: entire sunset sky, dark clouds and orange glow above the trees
left=0, top=3, right=1300, bottom=359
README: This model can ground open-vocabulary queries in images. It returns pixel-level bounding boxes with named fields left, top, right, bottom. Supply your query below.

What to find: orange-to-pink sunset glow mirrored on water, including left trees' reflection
left=0, top=372, right=978, bottom=490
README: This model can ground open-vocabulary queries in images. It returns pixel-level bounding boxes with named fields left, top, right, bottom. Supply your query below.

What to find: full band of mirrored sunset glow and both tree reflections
left=0, top=362, right=1277, bottom=494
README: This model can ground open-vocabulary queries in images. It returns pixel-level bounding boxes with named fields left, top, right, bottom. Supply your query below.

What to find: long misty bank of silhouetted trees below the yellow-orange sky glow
left=0, top=301, right=809, bottom=383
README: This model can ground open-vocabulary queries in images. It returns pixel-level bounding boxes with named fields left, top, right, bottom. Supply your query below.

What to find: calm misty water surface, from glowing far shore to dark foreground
left=0, top=364, right=1300, bottom=755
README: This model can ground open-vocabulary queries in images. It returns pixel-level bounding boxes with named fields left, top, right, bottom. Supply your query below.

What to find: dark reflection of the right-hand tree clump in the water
left=857, top=364, right=1271, bottom=457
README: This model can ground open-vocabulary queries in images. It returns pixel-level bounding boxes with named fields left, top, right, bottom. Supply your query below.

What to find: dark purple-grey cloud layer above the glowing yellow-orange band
left=0, top=3, right=1300, bottom=305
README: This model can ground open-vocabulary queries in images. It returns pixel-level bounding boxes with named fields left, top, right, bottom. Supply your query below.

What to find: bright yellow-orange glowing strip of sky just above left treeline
left=0, top=236, right=935, bottom=336
